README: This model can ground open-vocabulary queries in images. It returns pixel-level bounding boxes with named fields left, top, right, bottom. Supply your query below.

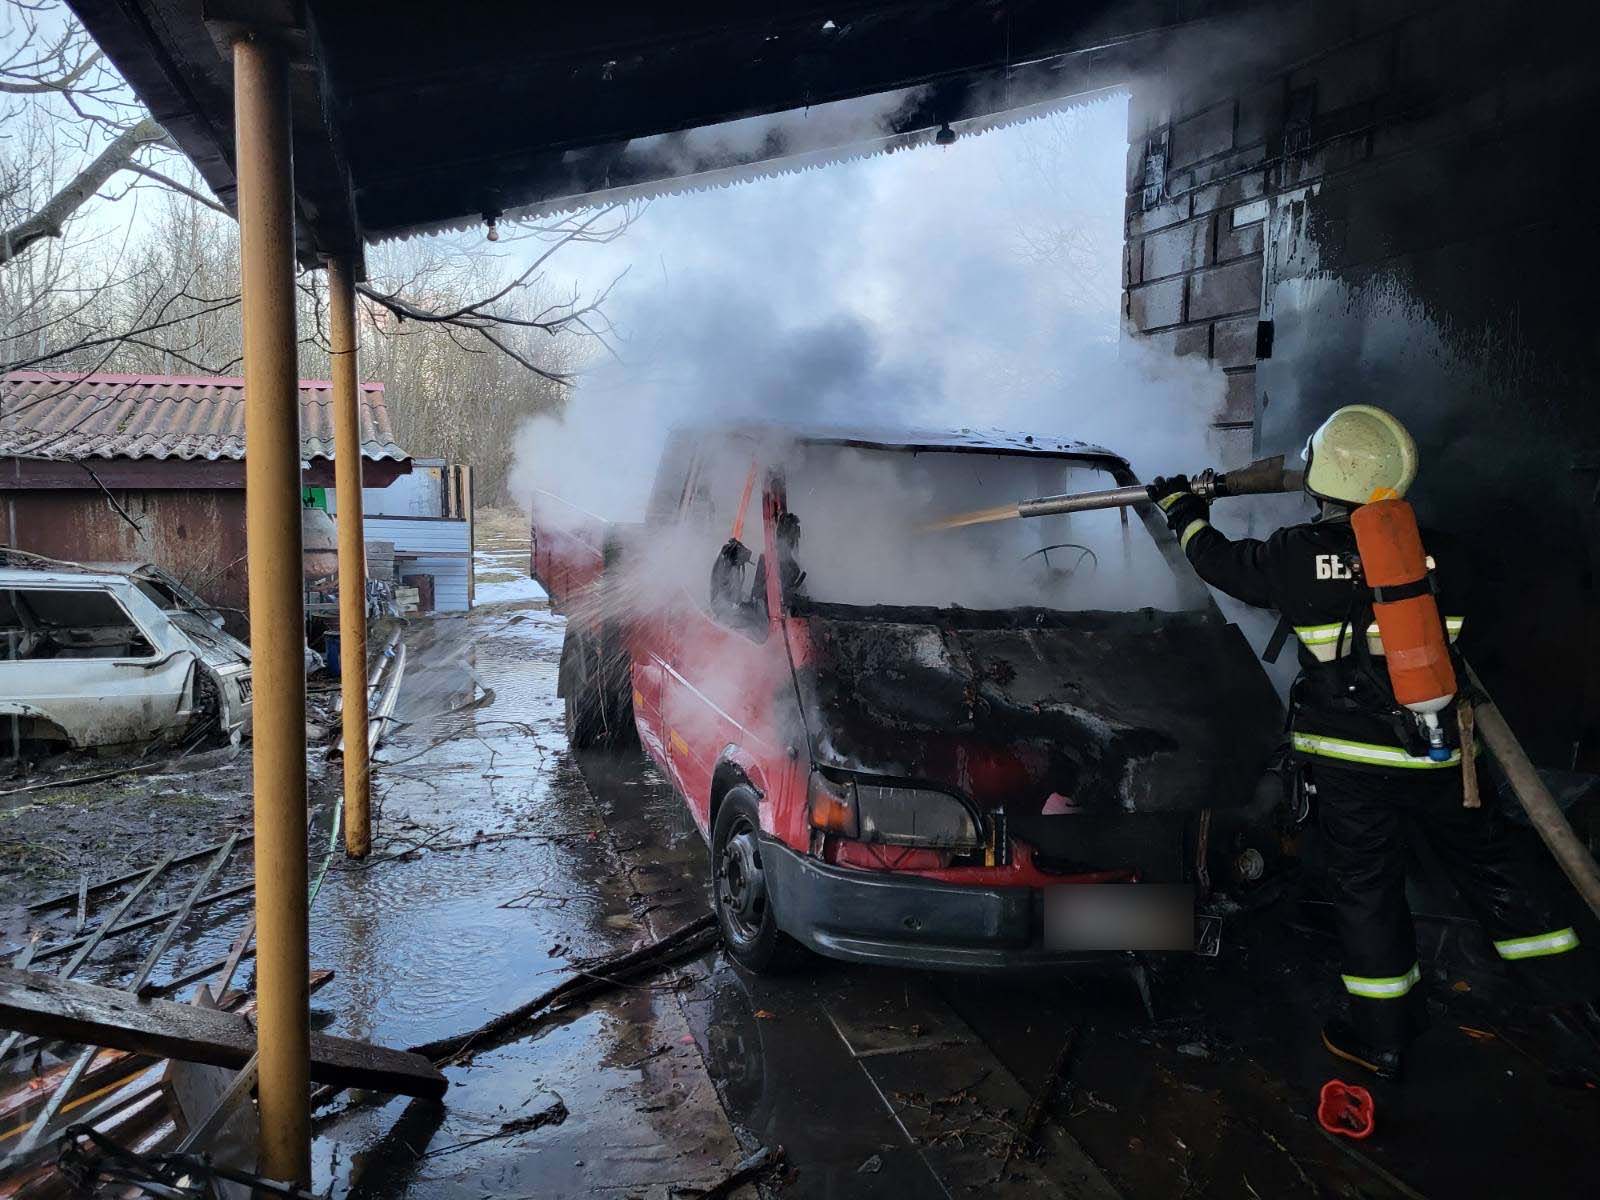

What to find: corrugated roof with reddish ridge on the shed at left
left=0, top=371, right=408, bottom=461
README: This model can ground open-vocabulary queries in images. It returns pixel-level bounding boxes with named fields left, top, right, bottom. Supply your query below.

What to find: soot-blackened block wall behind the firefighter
left=1125, top=0, right=1600, bottom=770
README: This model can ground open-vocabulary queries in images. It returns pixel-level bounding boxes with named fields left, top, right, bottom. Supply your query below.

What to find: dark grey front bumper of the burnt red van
left=762, top=837, right=1125, bottom=971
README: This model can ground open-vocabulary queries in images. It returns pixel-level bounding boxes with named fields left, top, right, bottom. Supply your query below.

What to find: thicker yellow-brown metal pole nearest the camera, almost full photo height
left=234, top=37, right=310, bottom=1184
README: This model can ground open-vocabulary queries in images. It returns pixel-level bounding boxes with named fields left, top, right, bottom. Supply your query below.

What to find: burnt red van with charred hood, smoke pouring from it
left=533, top=427, right=1282, bottom=971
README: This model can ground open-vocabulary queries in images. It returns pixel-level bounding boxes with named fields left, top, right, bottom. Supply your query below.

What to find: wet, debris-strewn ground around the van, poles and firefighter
left=0, top=528, right=1600, bottom=1198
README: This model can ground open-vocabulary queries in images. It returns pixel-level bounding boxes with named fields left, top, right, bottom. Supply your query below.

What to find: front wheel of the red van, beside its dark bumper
left=710, top=784, right=805, bottom=974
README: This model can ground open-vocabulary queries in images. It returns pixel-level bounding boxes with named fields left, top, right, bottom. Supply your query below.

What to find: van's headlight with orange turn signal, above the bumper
left=808, top=771, right=984, bottom=851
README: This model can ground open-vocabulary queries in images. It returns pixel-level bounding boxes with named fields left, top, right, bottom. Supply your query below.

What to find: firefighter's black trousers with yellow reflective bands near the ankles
left=1310, top=760, right=1595, bottom=1048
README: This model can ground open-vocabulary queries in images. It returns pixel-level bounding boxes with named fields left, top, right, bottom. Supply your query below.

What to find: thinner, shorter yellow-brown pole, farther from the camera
left=328, top=254, right=373, bottom=858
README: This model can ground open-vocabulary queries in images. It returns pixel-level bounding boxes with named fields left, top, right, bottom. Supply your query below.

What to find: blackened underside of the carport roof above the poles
left=70, top=0, right=1253, bottom=256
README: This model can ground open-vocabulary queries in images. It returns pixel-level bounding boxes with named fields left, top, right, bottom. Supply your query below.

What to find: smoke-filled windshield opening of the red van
left=786, top=443, right=1203, bottom=611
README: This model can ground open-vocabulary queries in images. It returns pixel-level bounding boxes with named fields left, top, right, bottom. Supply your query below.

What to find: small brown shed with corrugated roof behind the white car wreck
left=0, top=371, right=411, bottom=614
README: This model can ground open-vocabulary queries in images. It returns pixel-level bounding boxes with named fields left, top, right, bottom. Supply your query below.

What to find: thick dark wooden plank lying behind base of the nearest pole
left=0, top=966, right=446, bottom=1099
